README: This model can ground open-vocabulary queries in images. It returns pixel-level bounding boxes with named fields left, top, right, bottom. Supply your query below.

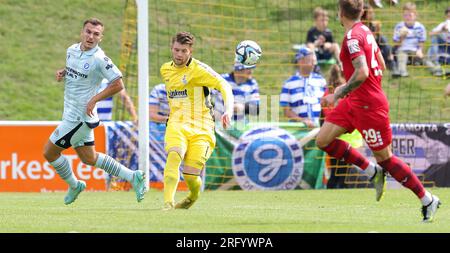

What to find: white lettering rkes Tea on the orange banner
left=0, top=153, right=105, bottom=180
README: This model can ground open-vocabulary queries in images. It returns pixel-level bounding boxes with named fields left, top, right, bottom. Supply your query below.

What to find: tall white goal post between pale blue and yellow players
left=136, top=0, right=150, bottom=190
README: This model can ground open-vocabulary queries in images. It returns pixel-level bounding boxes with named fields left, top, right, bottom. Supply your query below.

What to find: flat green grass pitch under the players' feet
left=0, top=188, right=450, bottom=233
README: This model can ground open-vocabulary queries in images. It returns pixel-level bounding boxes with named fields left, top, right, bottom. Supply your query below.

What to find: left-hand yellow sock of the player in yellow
left=164, top=151, right=181, bottom=203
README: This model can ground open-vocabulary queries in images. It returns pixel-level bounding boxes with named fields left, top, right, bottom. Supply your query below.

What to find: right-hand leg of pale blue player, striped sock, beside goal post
left=75, top=146, right=145, bottom=202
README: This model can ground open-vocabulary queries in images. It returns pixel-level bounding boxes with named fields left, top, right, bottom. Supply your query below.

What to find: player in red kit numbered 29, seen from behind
left=316, top=0, right=440, bottom=222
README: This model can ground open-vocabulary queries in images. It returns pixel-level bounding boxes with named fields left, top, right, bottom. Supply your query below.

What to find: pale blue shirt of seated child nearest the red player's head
left=392, top=22, right=427, bottom=51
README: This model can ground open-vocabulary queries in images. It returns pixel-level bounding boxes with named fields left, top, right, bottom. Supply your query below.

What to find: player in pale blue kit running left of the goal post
left=44, top=18, right=145, bottom=205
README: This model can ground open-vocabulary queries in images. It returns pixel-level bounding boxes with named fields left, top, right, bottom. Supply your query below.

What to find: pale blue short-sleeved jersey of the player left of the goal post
left=63, top=43, right=122, bottom=122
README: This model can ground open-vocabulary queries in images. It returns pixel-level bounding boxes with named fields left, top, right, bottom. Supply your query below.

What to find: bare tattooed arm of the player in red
left=334, top=55, right=369, bottom=101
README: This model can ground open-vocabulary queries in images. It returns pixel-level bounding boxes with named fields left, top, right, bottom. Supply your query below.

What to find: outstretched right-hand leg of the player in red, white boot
left=373, top=147, right=441, bottom=222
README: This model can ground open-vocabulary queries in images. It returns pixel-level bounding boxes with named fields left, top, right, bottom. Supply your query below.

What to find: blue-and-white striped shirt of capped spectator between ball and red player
left=280, top=72, right=327, bottom=125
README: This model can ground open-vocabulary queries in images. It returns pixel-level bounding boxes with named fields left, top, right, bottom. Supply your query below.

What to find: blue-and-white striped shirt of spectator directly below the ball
left=211, top=73, right=259, bottom=120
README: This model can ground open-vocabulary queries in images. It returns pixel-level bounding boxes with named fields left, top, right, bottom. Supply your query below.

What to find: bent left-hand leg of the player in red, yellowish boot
left=316, top=122, right=386, bottom=201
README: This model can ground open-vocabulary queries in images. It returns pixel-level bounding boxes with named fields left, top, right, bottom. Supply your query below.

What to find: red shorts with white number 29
left=325, top=99, right=392, bottom=151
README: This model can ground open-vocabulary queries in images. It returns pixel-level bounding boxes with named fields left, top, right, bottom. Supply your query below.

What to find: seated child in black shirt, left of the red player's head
left=306, top=7, right=340, bottom=65
